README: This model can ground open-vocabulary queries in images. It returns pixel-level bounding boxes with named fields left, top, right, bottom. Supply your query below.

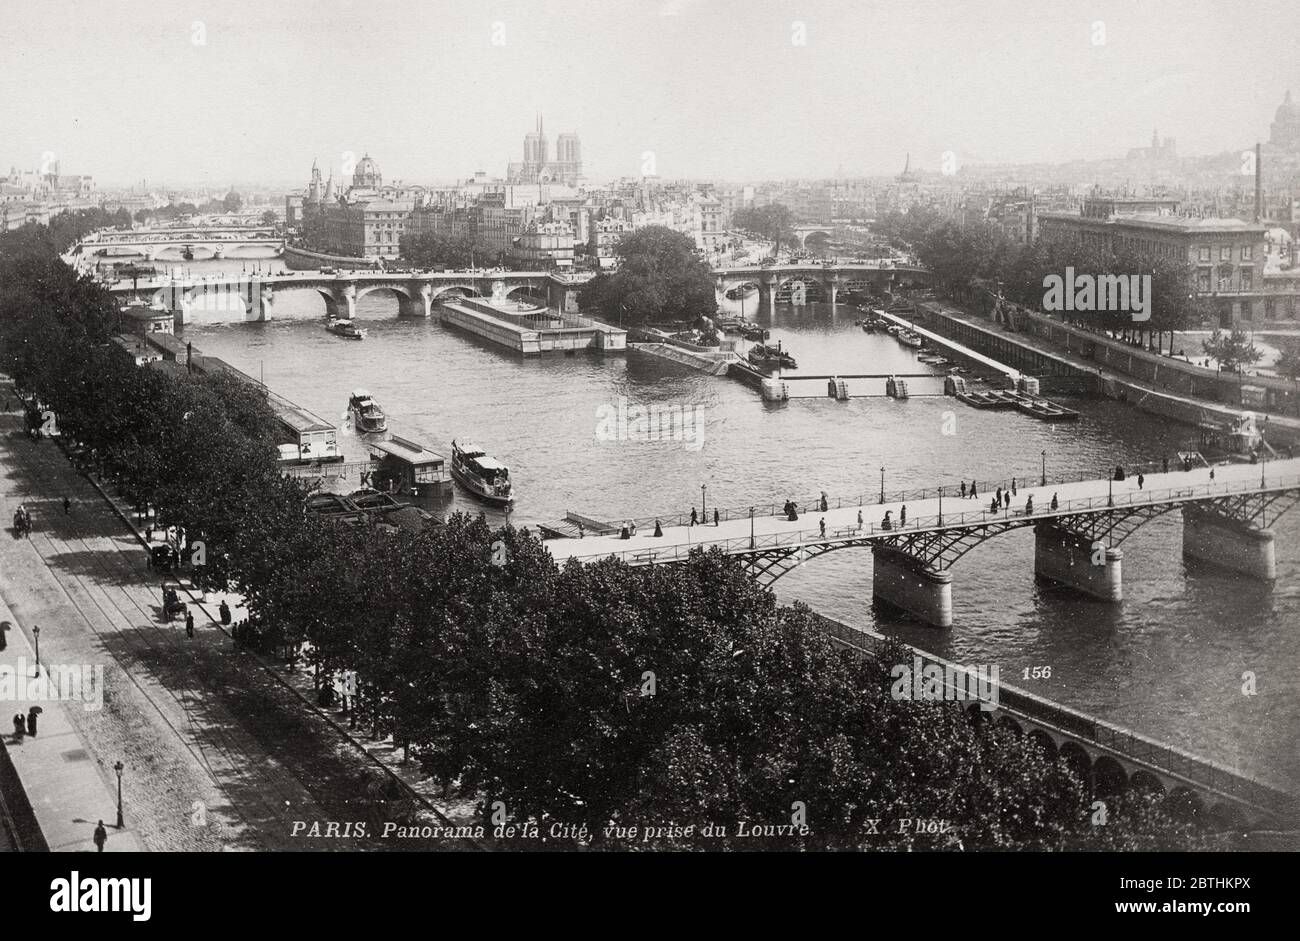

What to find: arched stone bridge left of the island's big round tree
left=109, top=269, right=585, bottom=320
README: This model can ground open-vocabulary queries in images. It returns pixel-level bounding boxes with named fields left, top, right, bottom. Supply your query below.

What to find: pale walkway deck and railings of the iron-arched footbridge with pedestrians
left=559, top=476, right=1300, bottom=564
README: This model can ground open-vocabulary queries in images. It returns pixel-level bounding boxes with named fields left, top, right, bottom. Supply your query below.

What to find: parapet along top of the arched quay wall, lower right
left=816, top=615, right=1300, bottom=821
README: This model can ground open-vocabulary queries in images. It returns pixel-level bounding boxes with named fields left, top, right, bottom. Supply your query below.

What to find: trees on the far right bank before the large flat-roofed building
left=879, top=207, right=1208, bottom=347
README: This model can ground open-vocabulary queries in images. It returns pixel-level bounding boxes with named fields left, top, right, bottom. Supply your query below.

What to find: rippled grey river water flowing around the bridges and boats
left=170, top=261, right=1300, bottom=786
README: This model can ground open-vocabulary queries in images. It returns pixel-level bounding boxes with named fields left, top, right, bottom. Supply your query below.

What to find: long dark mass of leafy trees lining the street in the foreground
left=0, top=214, right=1216, bottom=849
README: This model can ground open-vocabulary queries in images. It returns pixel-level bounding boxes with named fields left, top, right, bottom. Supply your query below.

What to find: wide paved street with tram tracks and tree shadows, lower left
left=0, top=383, right=460, bottom=851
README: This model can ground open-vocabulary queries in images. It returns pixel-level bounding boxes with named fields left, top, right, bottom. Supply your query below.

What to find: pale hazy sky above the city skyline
left=0, top=0, right=1300, bottom=185
